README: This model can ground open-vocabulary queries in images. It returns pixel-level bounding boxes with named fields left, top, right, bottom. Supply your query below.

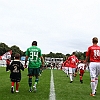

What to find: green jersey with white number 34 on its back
left=26, top=46, right=42, bottom=68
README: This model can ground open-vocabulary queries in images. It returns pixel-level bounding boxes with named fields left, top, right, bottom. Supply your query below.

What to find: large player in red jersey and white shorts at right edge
left=86, top=37, right=100, bottom=96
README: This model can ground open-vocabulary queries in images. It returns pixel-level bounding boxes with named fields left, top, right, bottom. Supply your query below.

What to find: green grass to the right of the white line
left=53, top=70, right=100, bottom=100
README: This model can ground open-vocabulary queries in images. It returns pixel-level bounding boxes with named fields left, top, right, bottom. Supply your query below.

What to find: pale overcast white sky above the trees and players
left=0, top=0, right=100, bottom=54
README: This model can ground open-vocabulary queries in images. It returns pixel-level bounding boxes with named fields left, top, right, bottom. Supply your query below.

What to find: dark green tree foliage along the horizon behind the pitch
left=0, top=43, right=86, bottom=61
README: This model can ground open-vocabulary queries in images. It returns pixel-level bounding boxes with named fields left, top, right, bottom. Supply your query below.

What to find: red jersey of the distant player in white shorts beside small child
left=68, top=55, right=78, bottom=68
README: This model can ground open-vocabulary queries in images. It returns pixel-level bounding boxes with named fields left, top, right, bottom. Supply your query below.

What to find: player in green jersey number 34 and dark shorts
left=25, top=41, right=44, bottom=92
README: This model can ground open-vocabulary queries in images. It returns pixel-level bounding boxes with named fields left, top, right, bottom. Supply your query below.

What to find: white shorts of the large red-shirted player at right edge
left=89, top=62, right=100, bottom=78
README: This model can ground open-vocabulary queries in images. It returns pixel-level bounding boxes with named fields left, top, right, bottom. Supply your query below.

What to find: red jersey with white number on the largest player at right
left=86, top=45, right=100, bottom=62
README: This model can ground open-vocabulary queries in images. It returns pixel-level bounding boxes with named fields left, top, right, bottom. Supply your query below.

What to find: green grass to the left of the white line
left=0, top=67, right=50, bottom=100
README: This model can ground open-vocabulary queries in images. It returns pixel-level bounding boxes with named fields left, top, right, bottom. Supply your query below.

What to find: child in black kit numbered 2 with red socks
left=9, top=53, right=24, bottom=93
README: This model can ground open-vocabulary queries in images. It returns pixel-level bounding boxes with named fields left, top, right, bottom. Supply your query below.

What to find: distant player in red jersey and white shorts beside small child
left=67, top=52, right=78, bottom=83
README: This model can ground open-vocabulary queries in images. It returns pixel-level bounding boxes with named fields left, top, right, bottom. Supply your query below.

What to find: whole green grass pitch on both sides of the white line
left=0, top=67, right=100, bottom=100
